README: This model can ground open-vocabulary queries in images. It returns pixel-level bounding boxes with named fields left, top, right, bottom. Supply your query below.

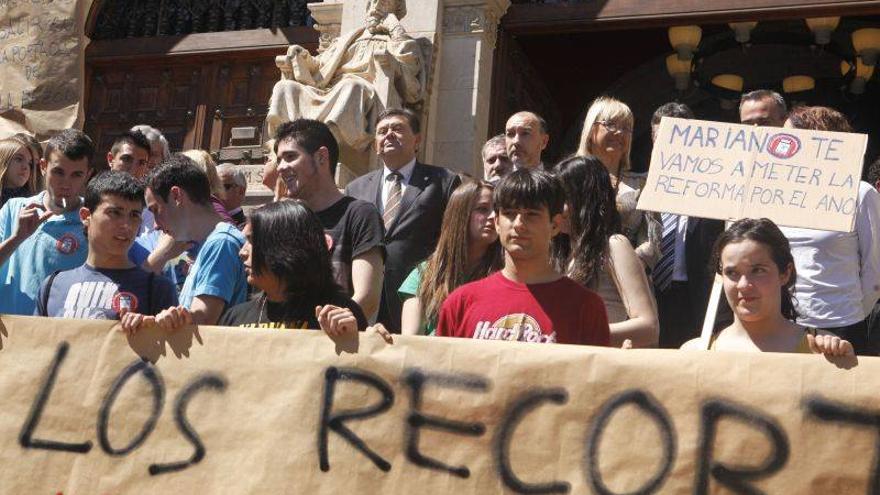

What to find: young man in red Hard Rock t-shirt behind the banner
left=437, top=169, right=609, bottom=346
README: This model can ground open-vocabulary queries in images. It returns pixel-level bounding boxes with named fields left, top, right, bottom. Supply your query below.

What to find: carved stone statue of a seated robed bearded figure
left=266, top=0, right=425, bottom=151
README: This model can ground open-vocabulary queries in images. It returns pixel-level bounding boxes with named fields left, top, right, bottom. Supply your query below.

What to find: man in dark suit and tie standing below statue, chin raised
left=345, top=109, right=461, bottom=333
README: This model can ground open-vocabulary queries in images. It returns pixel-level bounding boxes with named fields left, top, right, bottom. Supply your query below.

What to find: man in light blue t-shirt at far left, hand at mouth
left=0, top=129, right=95, bottom=315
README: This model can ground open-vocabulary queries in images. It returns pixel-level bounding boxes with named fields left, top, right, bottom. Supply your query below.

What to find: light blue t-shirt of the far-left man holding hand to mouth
left=0, top=191, right=89, bottom=315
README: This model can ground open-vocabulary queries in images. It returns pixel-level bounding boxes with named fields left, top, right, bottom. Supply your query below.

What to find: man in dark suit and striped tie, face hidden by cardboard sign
left=651, top=103, right=732, bottom=348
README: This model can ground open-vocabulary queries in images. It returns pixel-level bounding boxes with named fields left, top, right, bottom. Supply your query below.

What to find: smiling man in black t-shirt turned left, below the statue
left=275, top=119, right=385, bottom=318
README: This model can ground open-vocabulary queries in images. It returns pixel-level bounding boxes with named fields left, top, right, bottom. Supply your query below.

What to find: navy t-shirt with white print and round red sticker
left=34, top=264, right=177, bottom=320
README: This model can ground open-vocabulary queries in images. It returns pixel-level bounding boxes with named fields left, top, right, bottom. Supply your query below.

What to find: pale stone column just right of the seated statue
left=426, top=0, right=510, bottom=177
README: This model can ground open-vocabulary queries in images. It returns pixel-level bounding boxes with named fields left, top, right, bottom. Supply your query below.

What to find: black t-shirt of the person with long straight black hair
left=223, top=294, right=368, bottom=330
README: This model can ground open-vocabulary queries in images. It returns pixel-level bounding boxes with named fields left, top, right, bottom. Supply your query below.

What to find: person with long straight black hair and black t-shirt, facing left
left=218, top=201, right=367, bottom=335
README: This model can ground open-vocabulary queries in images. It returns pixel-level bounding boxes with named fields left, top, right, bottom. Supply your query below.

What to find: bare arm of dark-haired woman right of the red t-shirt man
left=606, top=236, right=660, bottom=347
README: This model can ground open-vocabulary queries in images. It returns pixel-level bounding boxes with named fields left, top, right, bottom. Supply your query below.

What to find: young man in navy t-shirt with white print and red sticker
left=35, top=171, right=177, bottom=320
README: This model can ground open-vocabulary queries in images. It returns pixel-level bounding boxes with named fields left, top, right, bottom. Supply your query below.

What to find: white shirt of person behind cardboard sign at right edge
left=781, top=182, right=880, bottom=328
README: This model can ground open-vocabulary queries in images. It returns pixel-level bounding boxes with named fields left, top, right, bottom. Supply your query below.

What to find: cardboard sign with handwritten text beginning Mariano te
left=638, top=117, right=868, bottom=232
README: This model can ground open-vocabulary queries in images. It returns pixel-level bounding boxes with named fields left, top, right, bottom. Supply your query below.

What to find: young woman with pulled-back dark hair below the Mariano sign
left=681, top=218, right=853, bottom=356
